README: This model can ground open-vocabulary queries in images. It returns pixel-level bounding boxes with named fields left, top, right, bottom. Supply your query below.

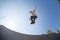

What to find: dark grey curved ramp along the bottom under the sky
left=0, top=25, right=60, bottom=40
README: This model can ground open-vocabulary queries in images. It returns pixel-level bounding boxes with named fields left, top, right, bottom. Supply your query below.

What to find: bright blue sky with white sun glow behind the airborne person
left=0, top=0, right=60, bottom=35
